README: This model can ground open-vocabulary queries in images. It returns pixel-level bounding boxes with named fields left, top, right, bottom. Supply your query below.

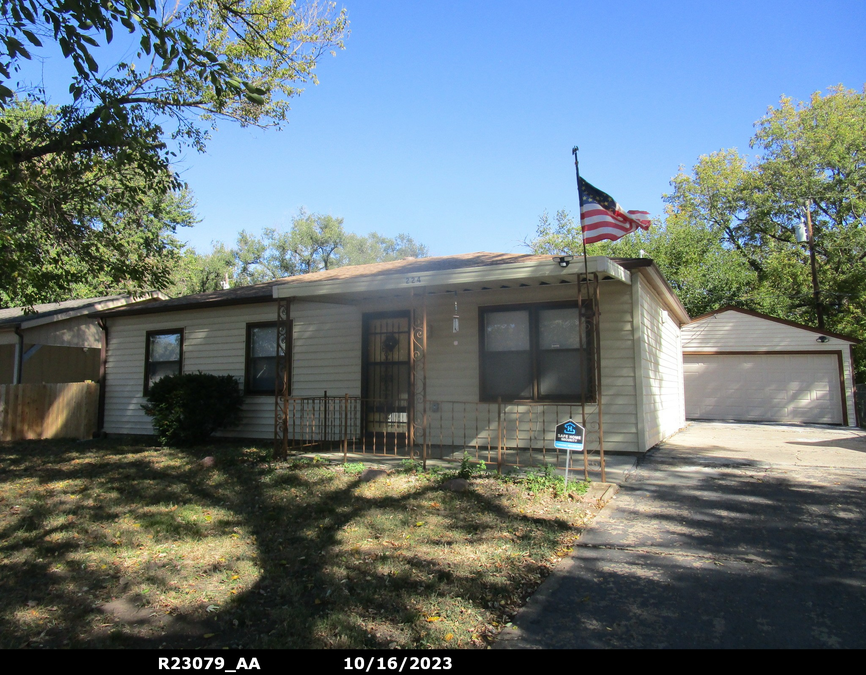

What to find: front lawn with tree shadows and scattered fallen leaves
left=0, top=441, right=592, bottom=649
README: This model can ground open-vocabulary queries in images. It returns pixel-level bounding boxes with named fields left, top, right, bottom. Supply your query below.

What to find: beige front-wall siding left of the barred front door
left=105, top=302, right=360, bottom=438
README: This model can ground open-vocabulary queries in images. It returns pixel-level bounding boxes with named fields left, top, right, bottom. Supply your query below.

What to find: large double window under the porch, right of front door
left=479, top=304, right=594, bottom=401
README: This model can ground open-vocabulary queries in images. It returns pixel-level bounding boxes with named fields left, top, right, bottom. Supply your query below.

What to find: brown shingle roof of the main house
left=96, top=251, right=688, bottom=321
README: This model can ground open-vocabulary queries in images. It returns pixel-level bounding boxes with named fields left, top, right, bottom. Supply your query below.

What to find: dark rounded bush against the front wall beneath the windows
left=141, top=372, right=243, bottom=445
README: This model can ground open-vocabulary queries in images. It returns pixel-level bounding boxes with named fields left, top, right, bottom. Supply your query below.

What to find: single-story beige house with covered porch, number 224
left=101, top=252, right=689, bottom=460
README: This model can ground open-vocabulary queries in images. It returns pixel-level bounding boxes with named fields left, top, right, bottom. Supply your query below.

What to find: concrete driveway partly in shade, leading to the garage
left=496, top=423, right=866, bottom=649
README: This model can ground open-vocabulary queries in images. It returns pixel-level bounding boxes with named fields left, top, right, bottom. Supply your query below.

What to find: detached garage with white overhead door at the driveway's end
left=682, top=307, right=859, bottom=426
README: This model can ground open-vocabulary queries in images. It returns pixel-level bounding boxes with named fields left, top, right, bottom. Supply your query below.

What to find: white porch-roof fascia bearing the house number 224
left=273, top=257, right=631, bottom=298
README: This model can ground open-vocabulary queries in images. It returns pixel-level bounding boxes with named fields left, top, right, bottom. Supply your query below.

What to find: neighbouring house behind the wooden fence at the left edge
left=0, top=291, right=166, bottom=384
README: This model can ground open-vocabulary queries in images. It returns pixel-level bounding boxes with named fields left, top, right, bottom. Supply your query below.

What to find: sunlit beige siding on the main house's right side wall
left=632, top=277, right=686, bottom=450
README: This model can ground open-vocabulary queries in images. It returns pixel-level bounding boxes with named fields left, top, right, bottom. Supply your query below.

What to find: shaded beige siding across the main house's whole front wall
left=105, top=281, right=643, bottom=452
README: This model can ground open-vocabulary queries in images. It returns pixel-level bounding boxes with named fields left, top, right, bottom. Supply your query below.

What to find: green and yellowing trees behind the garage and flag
left=529, top=86, right=866, bottom=381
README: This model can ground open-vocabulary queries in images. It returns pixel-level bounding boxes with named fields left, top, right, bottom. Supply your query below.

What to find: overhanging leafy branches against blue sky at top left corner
left=0, top=0, right=348, bottom=148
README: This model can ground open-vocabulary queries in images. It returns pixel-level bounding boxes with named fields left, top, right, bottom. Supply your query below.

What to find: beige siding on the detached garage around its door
left=683, top=310, right=856, bottom=426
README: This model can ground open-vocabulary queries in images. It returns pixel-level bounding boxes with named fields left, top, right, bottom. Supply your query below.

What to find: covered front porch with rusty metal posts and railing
left=266, top=256, right=652, bottom=480
